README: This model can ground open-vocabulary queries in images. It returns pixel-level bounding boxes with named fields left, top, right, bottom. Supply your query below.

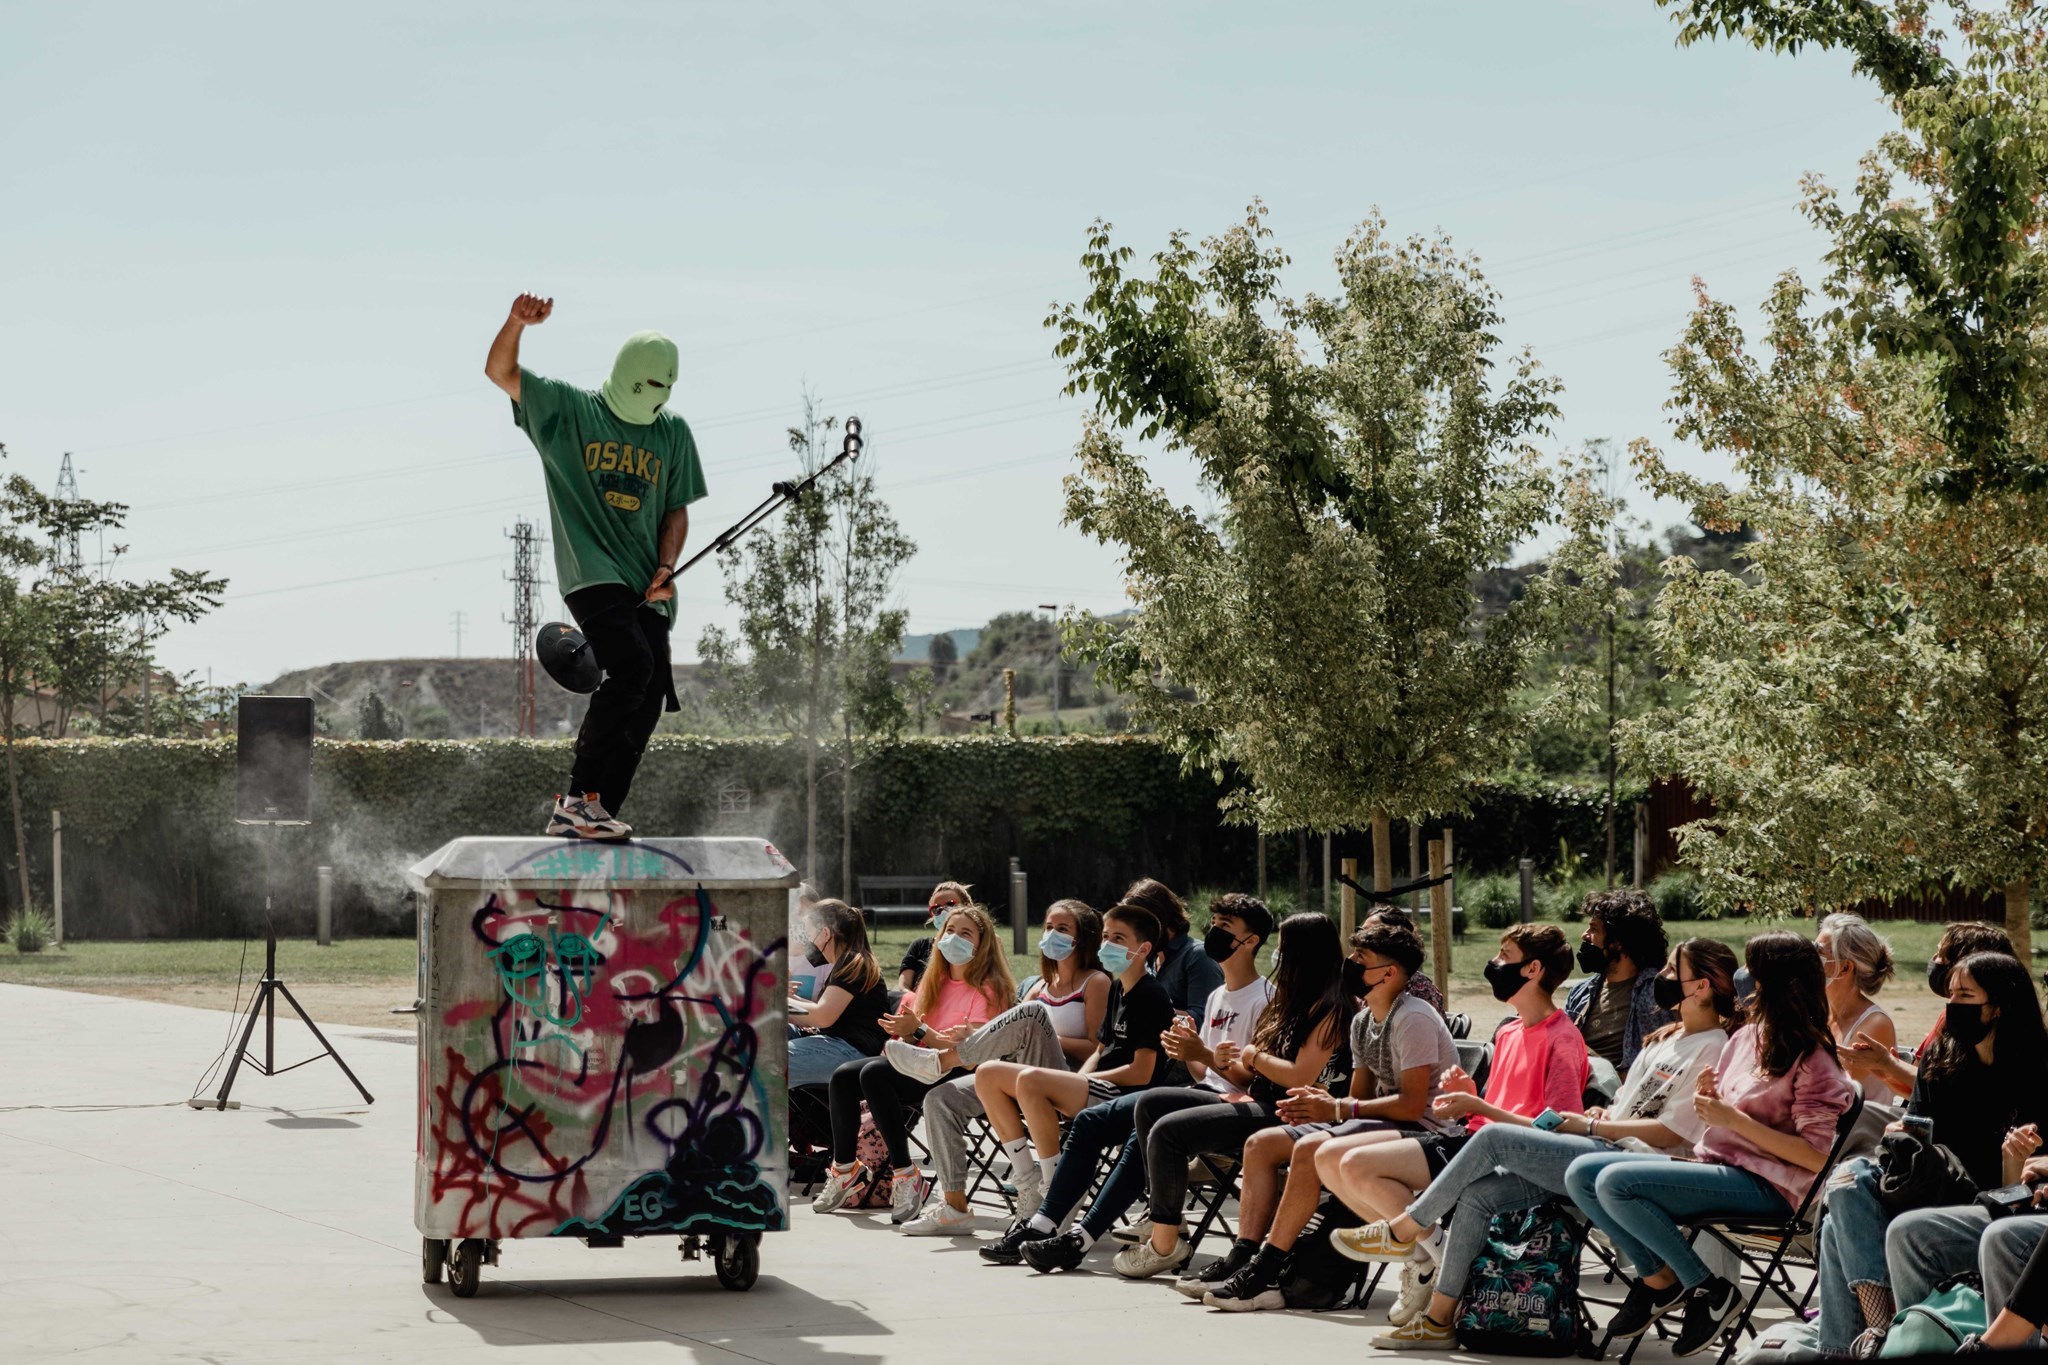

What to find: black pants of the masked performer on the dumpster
left=563, top=583, right=682, bottom=814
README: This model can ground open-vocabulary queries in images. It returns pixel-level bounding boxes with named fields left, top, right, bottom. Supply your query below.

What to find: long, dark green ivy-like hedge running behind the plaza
left=4, top=735, right=1626, bottom=937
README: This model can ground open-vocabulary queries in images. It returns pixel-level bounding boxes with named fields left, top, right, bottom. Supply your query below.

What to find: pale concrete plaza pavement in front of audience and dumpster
left=0, top=986, right=1728, bottom=1365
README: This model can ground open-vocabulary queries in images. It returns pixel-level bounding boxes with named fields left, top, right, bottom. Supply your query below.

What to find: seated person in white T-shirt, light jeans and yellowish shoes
left=1343, top=939, right=1735, bottom=1345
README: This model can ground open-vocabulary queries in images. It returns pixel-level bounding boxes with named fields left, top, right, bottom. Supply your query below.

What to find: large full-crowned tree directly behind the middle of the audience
left=1047, top=205, right=1606, bottom=908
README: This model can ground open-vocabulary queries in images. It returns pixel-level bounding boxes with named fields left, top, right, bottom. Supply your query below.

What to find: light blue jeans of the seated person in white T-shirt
left=1409, top=1124, right=1614, bottom=1297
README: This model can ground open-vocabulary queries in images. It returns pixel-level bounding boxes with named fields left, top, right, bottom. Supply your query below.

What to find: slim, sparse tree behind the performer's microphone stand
left=696, top=395, right=915, bottom=892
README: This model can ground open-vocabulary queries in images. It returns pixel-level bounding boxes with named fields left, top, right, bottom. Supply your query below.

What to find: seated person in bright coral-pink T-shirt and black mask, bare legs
left=1317, top=925, right=1587, bottom=1347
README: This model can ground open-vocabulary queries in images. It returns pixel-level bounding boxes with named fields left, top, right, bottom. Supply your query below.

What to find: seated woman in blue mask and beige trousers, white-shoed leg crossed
left=883, top=900, right=1110, bottom=1236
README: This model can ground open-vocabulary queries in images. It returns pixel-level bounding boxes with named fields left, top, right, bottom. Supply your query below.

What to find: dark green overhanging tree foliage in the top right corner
left=1657, top=0, right=2048, bottom=501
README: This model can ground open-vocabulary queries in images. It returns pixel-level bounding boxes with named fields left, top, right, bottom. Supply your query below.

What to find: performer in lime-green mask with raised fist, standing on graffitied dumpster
left=483, top=295, right=705, bottom=839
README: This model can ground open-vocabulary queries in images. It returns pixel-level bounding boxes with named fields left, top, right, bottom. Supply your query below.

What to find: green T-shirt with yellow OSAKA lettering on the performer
left=512, top=368, right=705, bottom=620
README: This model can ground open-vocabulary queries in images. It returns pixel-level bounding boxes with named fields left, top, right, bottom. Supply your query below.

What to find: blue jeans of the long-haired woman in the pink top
left=1565, top=1152, right=1792, bottom=1289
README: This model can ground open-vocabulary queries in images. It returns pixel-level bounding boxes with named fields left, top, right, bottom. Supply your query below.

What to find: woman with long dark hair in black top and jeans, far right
left=1819, top=952, right=2048, bottom=1355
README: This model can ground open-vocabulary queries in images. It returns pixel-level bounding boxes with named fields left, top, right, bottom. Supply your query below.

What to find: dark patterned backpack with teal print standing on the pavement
left=1456, top=1201, right=1593, bottom=1357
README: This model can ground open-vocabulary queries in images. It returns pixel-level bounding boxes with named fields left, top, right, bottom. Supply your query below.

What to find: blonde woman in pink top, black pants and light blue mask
left=811, top=905, right=1018, bottom=1224
